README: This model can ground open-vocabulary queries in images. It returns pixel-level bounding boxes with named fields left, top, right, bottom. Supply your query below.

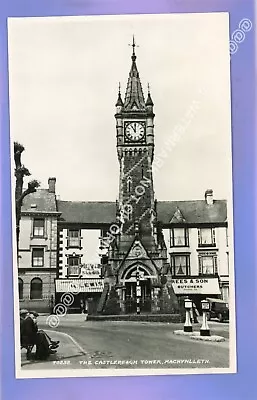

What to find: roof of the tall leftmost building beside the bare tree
left=21, top=189, right=57, bottom=213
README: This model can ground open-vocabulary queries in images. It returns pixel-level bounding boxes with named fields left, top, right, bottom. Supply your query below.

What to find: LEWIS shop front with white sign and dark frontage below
left=55, top=278, right=104, bottom=315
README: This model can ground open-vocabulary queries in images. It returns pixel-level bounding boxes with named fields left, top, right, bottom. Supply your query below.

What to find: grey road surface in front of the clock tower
left=21, top=316, right=229, bottom=369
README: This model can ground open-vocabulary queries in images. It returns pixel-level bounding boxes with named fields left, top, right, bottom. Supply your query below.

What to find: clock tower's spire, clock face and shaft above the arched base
left=115, top=37, right=155, bottom=236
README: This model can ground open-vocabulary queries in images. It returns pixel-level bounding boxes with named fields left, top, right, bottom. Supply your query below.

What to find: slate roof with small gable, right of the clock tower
left=157, top=200, right=227, bottom=224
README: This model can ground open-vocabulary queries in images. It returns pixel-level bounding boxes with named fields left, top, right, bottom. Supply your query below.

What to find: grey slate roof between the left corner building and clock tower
left=57, top=200, right=116, bottom=224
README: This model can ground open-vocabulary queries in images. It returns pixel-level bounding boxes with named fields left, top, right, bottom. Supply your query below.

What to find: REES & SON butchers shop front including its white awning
left=172, top=277, right=221, bottom=313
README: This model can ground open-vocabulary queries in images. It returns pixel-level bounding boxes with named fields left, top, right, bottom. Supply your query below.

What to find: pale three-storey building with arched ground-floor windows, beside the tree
left=18, top=178, right=59, bottom=312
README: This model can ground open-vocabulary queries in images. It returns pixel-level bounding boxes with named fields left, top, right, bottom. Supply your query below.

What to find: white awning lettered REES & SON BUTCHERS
left=172, top=278, right=220, bottom=295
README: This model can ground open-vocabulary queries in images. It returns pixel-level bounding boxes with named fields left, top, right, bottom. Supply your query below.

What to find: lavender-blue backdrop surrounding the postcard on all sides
left=0, top=0, right=257, bottom=400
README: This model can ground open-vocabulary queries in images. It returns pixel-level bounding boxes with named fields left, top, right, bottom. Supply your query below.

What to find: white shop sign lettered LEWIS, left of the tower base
left=55, top=279, right=104, bottom=293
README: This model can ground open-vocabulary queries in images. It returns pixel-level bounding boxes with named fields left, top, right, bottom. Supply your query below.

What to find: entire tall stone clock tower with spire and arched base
left=101, top=38, right=177, bottom=312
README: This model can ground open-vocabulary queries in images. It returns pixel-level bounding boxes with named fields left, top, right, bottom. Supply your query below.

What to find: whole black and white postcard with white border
left=8, top=13, right=236, bottom=378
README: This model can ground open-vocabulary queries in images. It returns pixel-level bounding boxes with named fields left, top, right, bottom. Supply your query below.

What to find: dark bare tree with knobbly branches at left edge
left=14, top=142, right=40, bottom=256
